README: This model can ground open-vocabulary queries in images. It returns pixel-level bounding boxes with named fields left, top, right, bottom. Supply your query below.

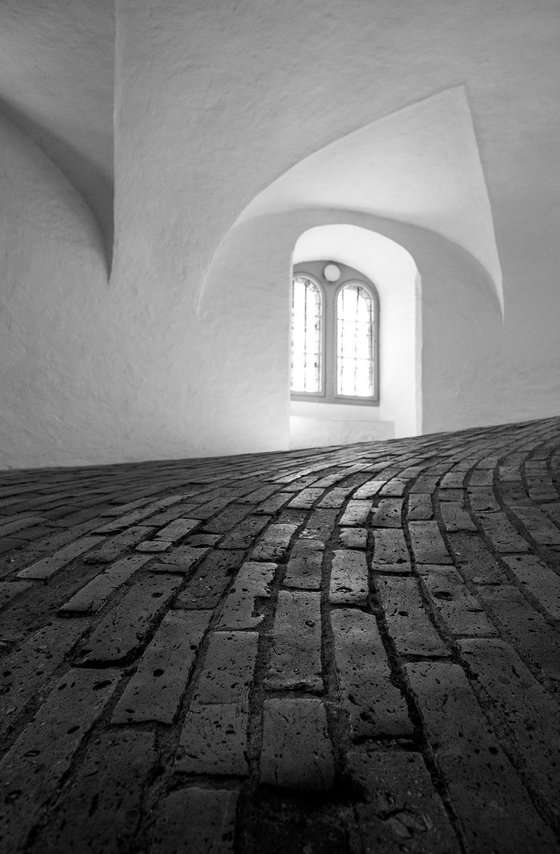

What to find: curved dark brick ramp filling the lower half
left=0, top=419, right=560, bottom=854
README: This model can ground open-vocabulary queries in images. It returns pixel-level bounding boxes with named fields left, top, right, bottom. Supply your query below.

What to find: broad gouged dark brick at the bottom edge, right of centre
left=348, top=749, right=462, bottom=854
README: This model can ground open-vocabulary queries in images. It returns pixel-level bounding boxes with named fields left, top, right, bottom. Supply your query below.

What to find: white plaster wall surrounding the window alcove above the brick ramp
left=0, top=0, right=560, bottom=466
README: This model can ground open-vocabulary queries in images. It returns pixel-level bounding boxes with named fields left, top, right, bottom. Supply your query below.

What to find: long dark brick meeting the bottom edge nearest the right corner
left=406, top=662, right=556, bottom=854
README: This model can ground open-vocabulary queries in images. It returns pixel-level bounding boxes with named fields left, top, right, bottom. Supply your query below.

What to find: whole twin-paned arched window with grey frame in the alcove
left=291, top=261, right=379, bottom=404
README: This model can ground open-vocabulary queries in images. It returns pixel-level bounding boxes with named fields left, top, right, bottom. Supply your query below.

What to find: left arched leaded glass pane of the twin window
left=292, top=276, right=323, bottom=394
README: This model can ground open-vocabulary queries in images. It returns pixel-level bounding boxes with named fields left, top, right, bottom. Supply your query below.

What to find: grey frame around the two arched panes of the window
left=290, top=259, right=380, bottom=406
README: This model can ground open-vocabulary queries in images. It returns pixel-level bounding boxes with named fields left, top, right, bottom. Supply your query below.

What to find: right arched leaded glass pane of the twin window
left=336, top=284, right=374, bottom=397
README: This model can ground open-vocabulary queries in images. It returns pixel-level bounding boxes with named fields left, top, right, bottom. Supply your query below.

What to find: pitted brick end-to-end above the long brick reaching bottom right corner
left=375, top=576, right=450, bottom=656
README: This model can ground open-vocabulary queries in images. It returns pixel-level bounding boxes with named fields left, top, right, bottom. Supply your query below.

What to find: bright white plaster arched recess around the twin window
left=290, top=223, right=422, bottom=448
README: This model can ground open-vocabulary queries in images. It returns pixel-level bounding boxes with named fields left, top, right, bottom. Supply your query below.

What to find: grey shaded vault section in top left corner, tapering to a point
left=0, top=0, right=115, bottom=254
